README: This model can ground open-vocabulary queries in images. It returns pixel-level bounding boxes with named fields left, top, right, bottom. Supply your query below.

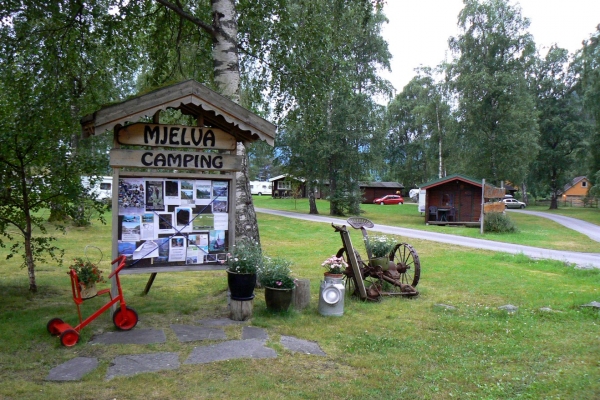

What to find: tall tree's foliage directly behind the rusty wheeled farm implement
left=240, top=0, right=389, bottom=215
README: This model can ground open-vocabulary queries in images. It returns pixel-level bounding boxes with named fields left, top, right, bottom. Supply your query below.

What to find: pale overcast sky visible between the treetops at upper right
left=381, top=0, right=600, bottom=92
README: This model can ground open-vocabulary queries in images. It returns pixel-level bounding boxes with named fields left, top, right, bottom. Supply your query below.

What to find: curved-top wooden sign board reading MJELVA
left=115, top=122, right=236, bottom=150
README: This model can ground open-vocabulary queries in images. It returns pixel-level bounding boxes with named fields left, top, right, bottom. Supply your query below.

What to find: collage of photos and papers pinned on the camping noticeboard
left=118, top=177, right=229, bottom=267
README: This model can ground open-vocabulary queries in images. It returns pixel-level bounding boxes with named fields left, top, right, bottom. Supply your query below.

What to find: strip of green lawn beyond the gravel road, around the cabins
left=253, top=196, right=600, bottom=253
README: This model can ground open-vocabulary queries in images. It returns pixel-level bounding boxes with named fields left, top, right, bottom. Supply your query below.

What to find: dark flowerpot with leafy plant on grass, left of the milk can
left=258, top=257, right=296, bottom=311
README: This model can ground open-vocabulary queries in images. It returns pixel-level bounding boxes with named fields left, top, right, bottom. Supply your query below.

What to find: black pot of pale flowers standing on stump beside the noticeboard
left=227, top=240, right=263, bottom=301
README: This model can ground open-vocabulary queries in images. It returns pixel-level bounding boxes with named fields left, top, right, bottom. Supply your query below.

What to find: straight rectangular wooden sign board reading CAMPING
left=110, top=149, right=242, bottom=171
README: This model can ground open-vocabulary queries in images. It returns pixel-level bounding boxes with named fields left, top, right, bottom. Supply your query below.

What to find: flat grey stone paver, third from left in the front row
left=184, top=339, right=277, bottom=364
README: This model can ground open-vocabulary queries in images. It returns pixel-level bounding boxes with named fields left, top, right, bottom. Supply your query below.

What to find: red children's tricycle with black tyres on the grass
left=46, top=256, right=138, bottom=347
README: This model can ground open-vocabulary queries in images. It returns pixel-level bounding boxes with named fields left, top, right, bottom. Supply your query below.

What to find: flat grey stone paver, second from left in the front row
left=106, top=353, right=180, bottom=380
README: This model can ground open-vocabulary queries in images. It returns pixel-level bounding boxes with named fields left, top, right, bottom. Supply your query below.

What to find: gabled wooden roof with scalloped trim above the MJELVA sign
left=81, top=80, right=277, bottom=146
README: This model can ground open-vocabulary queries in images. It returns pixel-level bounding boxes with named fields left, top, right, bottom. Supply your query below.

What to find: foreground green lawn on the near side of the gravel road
left=0, top=211, right=600, bottom=400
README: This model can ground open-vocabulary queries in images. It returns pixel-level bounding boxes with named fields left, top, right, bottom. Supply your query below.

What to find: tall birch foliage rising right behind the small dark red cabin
left=449, top=0, right=539, bottom=183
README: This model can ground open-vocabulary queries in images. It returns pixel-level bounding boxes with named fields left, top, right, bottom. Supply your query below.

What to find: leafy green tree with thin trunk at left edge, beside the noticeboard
left=0, top=1, right=137, bottom=292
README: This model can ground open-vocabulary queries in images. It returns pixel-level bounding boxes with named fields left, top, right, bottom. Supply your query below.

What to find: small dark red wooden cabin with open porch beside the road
left=420, top=174, right=482, bottom=226
